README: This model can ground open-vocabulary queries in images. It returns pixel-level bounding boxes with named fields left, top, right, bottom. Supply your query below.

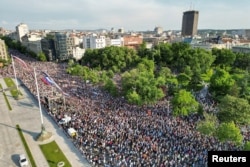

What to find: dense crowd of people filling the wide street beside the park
left=2, top=52, right=246, bottom=167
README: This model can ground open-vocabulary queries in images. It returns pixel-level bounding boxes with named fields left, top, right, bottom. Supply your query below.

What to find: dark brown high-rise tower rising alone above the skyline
left=181, top=10, right=199, bottom=36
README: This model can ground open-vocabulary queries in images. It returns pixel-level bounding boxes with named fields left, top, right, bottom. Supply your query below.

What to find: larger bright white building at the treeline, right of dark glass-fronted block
left=83, top=34, right=106, bottom=49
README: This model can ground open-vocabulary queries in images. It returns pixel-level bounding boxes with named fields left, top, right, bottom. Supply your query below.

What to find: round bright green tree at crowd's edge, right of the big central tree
left=171, top=89, right=199, bottom=116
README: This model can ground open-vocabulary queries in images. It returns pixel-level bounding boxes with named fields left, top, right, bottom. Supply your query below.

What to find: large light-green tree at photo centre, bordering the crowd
left=122, top=59, right=165, bottom=104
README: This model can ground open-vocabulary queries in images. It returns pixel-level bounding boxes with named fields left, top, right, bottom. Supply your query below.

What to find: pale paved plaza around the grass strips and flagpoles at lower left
left=0, top=79, right=90, bottom=167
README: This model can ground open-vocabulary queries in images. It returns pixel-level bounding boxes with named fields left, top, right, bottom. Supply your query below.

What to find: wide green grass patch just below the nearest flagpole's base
left=40, top=141, right=71, bottom=167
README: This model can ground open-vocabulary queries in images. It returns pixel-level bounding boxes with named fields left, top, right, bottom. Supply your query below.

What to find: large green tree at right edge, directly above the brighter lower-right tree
left=218, top=95, right=250, bottom=125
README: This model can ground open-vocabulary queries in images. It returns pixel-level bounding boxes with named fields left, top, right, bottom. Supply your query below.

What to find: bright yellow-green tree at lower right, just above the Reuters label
left=216, top=122, right=243, bottom=145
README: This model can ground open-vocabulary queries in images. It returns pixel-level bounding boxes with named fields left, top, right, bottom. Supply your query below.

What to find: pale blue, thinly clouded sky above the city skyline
left=0, top=0, right=250, bottom=31
